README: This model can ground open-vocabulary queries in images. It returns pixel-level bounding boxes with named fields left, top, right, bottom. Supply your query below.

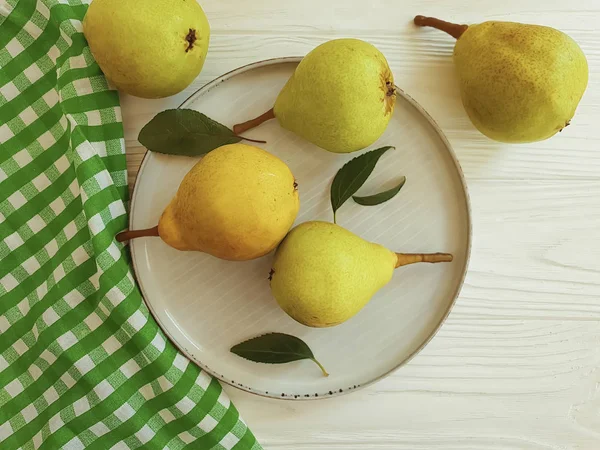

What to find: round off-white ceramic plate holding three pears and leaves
left=130, top=58, right=471, bottom=399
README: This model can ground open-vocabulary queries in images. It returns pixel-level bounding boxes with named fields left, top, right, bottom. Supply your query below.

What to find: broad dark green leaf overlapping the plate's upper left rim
left=138, top=109, right=242, bottom=156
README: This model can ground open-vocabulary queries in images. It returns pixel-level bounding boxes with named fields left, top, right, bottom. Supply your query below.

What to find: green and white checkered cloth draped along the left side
left=0, top=0, right=260, bottom=450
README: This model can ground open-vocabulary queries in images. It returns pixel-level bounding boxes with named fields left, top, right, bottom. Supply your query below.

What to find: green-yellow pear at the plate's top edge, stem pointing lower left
left=234, top=39, right=396, bottom=153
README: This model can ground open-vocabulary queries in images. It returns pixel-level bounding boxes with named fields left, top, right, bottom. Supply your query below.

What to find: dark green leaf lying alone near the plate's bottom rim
left=231, top=333, right=329, bottom=377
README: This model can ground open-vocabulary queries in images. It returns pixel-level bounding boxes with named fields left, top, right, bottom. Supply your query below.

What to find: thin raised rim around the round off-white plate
left=129, top=56, right=473, bottom=401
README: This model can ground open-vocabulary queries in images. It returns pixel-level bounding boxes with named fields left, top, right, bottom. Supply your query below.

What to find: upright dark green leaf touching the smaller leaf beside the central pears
left=331, top=146, right=394, bottom=222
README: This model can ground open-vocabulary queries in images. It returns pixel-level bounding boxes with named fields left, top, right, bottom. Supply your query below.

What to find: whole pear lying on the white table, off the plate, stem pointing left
left=415, top=16, right=588, bottom=143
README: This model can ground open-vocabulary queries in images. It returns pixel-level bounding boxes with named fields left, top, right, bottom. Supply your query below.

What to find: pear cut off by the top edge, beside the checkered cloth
left=83, top=0, right=210, bottom=98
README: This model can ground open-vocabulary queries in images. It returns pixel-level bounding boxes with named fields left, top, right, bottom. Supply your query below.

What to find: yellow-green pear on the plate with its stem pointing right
left=270, top=221, right=452, bottom=327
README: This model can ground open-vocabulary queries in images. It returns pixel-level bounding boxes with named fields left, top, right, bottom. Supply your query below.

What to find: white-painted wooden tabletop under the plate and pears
left=122, top=0, right=600, bottom=450
